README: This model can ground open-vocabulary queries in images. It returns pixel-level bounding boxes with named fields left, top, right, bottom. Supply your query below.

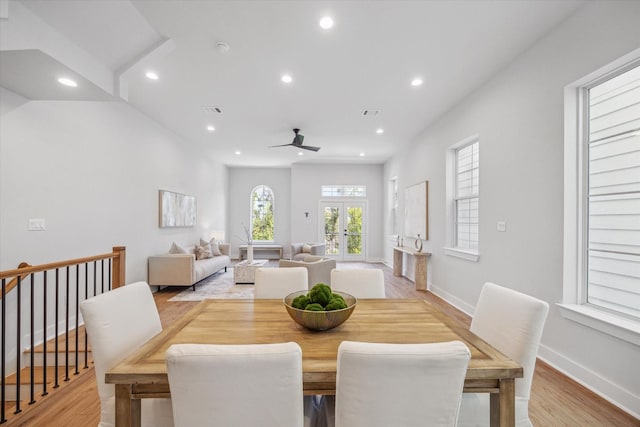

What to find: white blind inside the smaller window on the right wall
left=454, top=140, right=480, bottom=251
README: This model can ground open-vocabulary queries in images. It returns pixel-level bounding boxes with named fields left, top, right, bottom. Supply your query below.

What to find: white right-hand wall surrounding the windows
left=384, top=2, right=640, bottom=416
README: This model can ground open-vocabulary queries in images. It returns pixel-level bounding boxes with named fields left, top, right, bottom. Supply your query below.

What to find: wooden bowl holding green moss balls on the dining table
left=284, top=291, right=356, bottom=331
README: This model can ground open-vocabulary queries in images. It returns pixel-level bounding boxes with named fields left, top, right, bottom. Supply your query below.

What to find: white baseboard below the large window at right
left=538, top=344, right=640, bottom=419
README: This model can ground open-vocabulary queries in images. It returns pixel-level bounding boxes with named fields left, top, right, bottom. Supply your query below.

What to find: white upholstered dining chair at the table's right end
left=458, top=283, right=549, bottom=427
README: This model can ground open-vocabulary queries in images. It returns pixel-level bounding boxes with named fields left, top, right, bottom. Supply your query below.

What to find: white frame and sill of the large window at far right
left=557, top=49, right=640, bottom=345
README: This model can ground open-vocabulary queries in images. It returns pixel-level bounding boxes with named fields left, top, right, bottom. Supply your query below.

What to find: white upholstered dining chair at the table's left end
left=80, top=282, right=173, bottom=427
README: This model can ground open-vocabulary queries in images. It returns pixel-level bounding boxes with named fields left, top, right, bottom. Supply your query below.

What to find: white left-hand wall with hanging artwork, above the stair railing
left=0, top=88, right=227, bottom=372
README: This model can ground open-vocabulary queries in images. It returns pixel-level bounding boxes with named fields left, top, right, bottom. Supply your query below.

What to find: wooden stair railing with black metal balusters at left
left=0, top=246, right=126, bottom=424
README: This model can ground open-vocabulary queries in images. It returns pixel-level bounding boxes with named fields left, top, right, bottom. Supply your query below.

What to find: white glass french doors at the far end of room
left=320, top=202, right=366, bottom=261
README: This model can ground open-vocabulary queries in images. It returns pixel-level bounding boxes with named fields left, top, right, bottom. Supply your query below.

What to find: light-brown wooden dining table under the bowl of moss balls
left=105, top=299, right=522, bottom=427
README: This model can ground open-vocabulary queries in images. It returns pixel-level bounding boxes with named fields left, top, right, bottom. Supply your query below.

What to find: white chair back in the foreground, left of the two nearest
left=166, top=342, right=303, bottom=427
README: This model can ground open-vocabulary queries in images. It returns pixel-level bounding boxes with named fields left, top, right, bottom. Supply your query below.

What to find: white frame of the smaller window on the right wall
left=444, top=134, right=480, bottom=262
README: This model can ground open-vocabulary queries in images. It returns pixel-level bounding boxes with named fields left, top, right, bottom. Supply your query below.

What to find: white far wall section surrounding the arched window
left=226, top=167, right=291, bottom=258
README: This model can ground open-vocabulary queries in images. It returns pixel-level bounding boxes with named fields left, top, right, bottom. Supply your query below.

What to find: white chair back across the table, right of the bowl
left=331, top=268, right=385, bottom=298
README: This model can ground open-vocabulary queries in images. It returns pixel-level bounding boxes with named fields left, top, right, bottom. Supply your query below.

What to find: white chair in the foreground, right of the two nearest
left=316, top=341, right=471, bottom=427
